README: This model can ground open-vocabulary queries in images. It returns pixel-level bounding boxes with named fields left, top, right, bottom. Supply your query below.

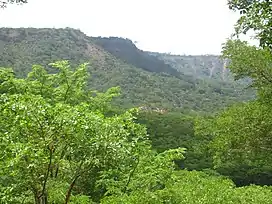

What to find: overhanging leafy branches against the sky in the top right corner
left=228, top=0, right=272, bottom=51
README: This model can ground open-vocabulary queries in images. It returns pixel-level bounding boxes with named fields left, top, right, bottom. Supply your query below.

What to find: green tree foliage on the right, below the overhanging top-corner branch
left=196, top=32, right=272, bottom=185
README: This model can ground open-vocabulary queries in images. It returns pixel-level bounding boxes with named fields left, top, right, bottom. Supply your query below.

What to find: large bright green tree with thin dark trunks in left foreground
left=0, top=61, right=183, bottom=204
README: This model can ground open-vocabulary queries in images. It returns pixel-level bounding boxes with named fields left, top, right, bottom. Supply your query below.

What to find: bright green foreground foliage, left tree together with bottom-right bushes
left=0, top=61, right=272, bottom=204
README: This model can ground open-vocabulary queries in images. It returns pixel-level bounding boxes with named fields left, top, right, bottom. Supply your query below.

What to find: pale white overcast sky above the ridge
left=0, top=0, right=258, bottom=55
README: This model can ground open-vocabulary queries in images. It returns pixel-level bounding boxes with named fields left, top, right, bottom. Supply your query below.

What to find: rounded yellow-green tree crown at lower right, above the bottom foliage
left=196, top=102, right=272, bottom=185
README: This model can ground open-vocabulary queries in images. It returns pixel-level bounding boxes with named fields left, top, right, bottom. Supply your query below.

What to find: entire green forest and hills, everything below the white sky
left=0, top=0, right=272, bottom=204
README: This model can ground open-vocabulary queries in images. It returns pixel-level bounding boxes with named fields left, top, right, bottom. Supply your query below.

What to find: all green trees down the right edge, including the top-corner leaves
left=193, top=0, right=272, bottom=184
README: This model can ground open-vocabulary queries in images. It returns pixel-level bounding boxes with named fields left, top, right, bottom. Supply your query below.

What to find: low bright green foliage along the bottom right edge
left=102, top=171, right=272, bottom=204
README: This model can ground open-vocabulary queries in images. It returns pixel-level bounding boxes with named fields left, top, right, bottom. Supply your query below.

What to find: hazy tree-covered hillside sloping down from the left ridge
left=0, top=28, right=253, bottom=111
